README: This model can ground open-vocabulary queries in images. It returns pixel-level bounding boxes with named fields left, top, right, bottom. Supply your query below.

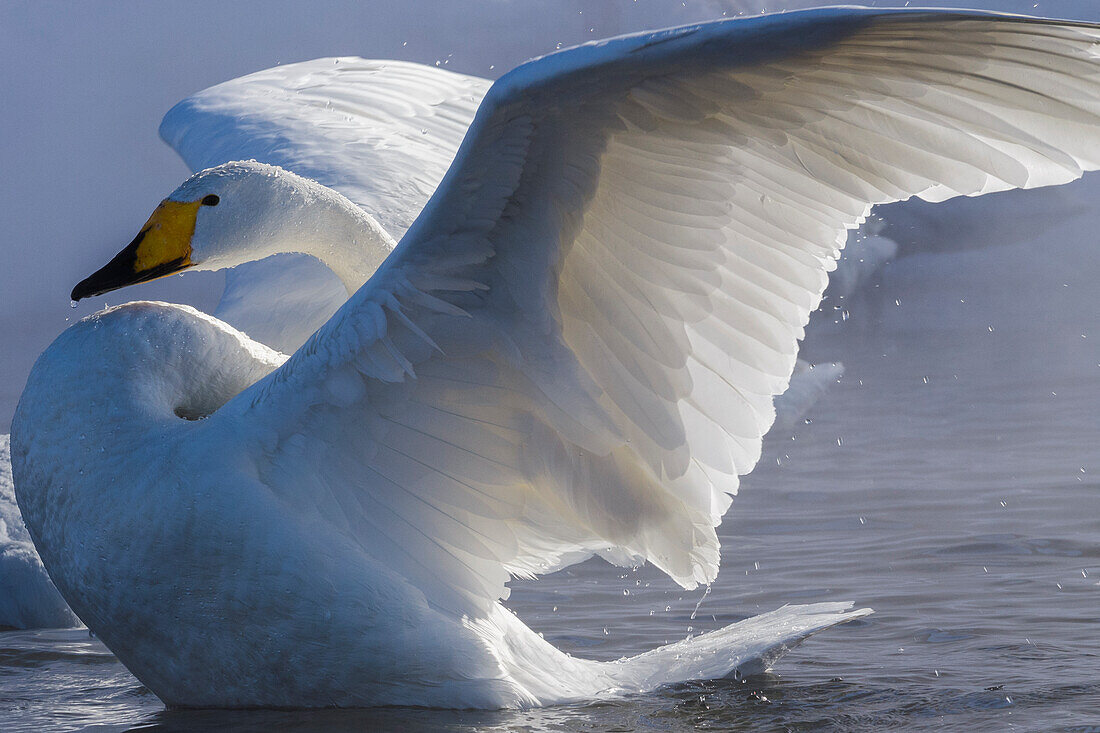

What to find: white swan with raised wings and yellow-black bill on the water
left=12, top=9, right=1100, bottom=707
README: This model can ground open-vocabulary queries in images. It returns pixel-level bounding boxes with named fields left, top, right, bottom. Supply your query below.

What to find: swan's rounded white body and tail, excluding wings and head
left=10, top=303, right=867, bottom=708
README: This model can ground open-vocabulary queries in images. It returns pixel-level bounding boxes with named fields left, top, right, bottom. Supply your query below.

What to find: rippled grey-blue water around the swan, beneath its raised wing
left=0, top=181, right=1100, bottom=732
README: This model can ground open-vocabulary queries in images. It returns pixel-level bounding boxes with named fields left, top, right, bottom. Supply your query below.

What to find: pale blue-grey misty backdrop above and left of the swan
left=0, top=0, right=1100, bottom=422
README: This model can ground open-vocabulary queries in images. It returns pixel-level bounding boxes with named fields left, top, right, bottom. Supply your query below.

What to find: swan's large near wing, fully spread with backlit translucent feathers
left=211, top=9, right=1100, bottom=612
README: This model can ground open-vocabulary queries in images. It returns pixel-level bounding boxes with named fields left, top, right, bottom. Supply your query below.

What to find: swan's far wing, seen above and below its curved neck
left=161, top=57, right=490, bottom=352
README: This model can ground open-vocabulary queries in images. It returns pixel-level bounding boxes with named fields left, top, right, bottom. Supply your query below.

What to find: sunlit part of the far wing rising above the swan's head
left=161, top=57, right=491, bottom=240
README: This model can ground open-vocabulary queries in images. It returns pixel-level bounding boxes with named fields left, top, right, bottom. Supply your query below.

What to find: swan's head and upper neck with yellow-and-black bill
left=72, top=161, right=356, bottom=300
